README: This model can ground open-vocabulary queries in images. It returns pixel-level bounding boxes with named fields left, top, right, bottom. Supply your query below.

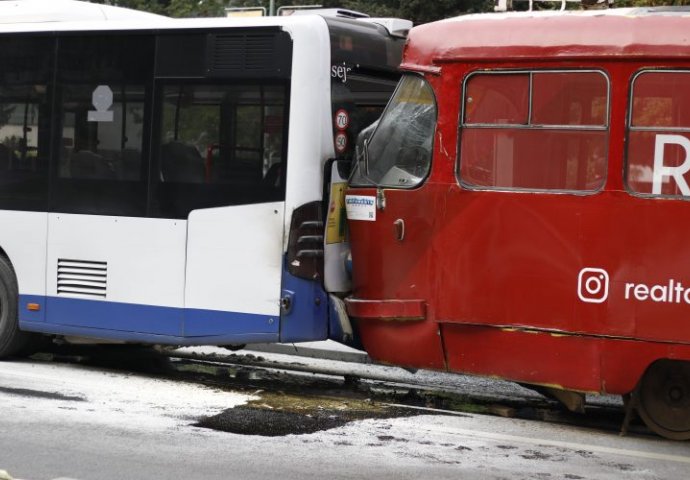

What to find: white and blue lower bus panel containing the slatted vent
left=46, top=213, right=187, bottom=335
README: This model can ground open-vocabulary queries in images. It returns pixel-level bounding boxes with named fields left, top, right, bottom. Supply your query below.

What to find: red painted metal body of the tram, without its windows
left=348, top=10, right=690, bottom=393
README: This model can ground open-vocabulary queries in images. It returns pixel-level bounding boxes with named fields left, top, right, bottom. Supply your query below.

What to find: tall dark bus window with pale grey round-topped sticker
left=52, top=35, right=153, bottom=216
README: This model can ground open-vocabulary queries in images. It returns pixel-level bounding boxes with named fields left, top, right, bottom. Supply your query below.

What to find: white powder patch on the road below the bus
left=0, top=361, right=254, bottom=430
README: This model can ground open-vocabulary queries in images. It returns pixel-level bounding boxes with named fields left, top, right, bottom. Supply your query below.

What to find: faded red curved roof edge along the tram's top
left=402, top=7, right=690, bottom=71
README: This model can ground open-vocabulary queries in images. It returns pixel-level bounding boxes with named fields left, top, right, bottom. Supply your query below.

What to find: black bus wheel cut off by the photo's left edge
left=0, top=255, right=34, bottom=358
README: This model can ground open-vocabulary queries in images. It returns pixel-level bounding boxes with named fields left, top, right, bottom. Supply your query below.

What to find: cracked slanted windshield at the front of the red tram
left=351, top=75, right=436, bottom=188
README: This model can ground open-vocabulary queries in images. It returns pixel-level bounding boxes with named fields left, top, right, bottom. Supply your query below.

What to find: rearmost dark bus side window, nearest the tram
left=154, top=83, right=287, bottom=218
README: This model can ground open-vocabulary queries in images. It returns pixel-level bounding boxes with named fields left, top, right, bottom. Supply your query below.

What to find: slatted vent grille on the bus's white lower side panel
left=57, top=258, right=108, bottom=298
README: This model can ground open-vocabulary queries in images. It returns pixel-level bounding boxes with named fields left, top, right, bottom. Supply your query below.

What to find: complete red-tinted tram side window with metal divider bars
left=460, top=71, right=609, bottom=192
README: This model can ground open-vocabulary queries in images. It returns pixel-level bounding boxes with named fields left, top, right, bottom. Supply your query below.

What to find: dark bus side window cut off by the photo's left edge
left=0, top=37, right=53, bottom=210
